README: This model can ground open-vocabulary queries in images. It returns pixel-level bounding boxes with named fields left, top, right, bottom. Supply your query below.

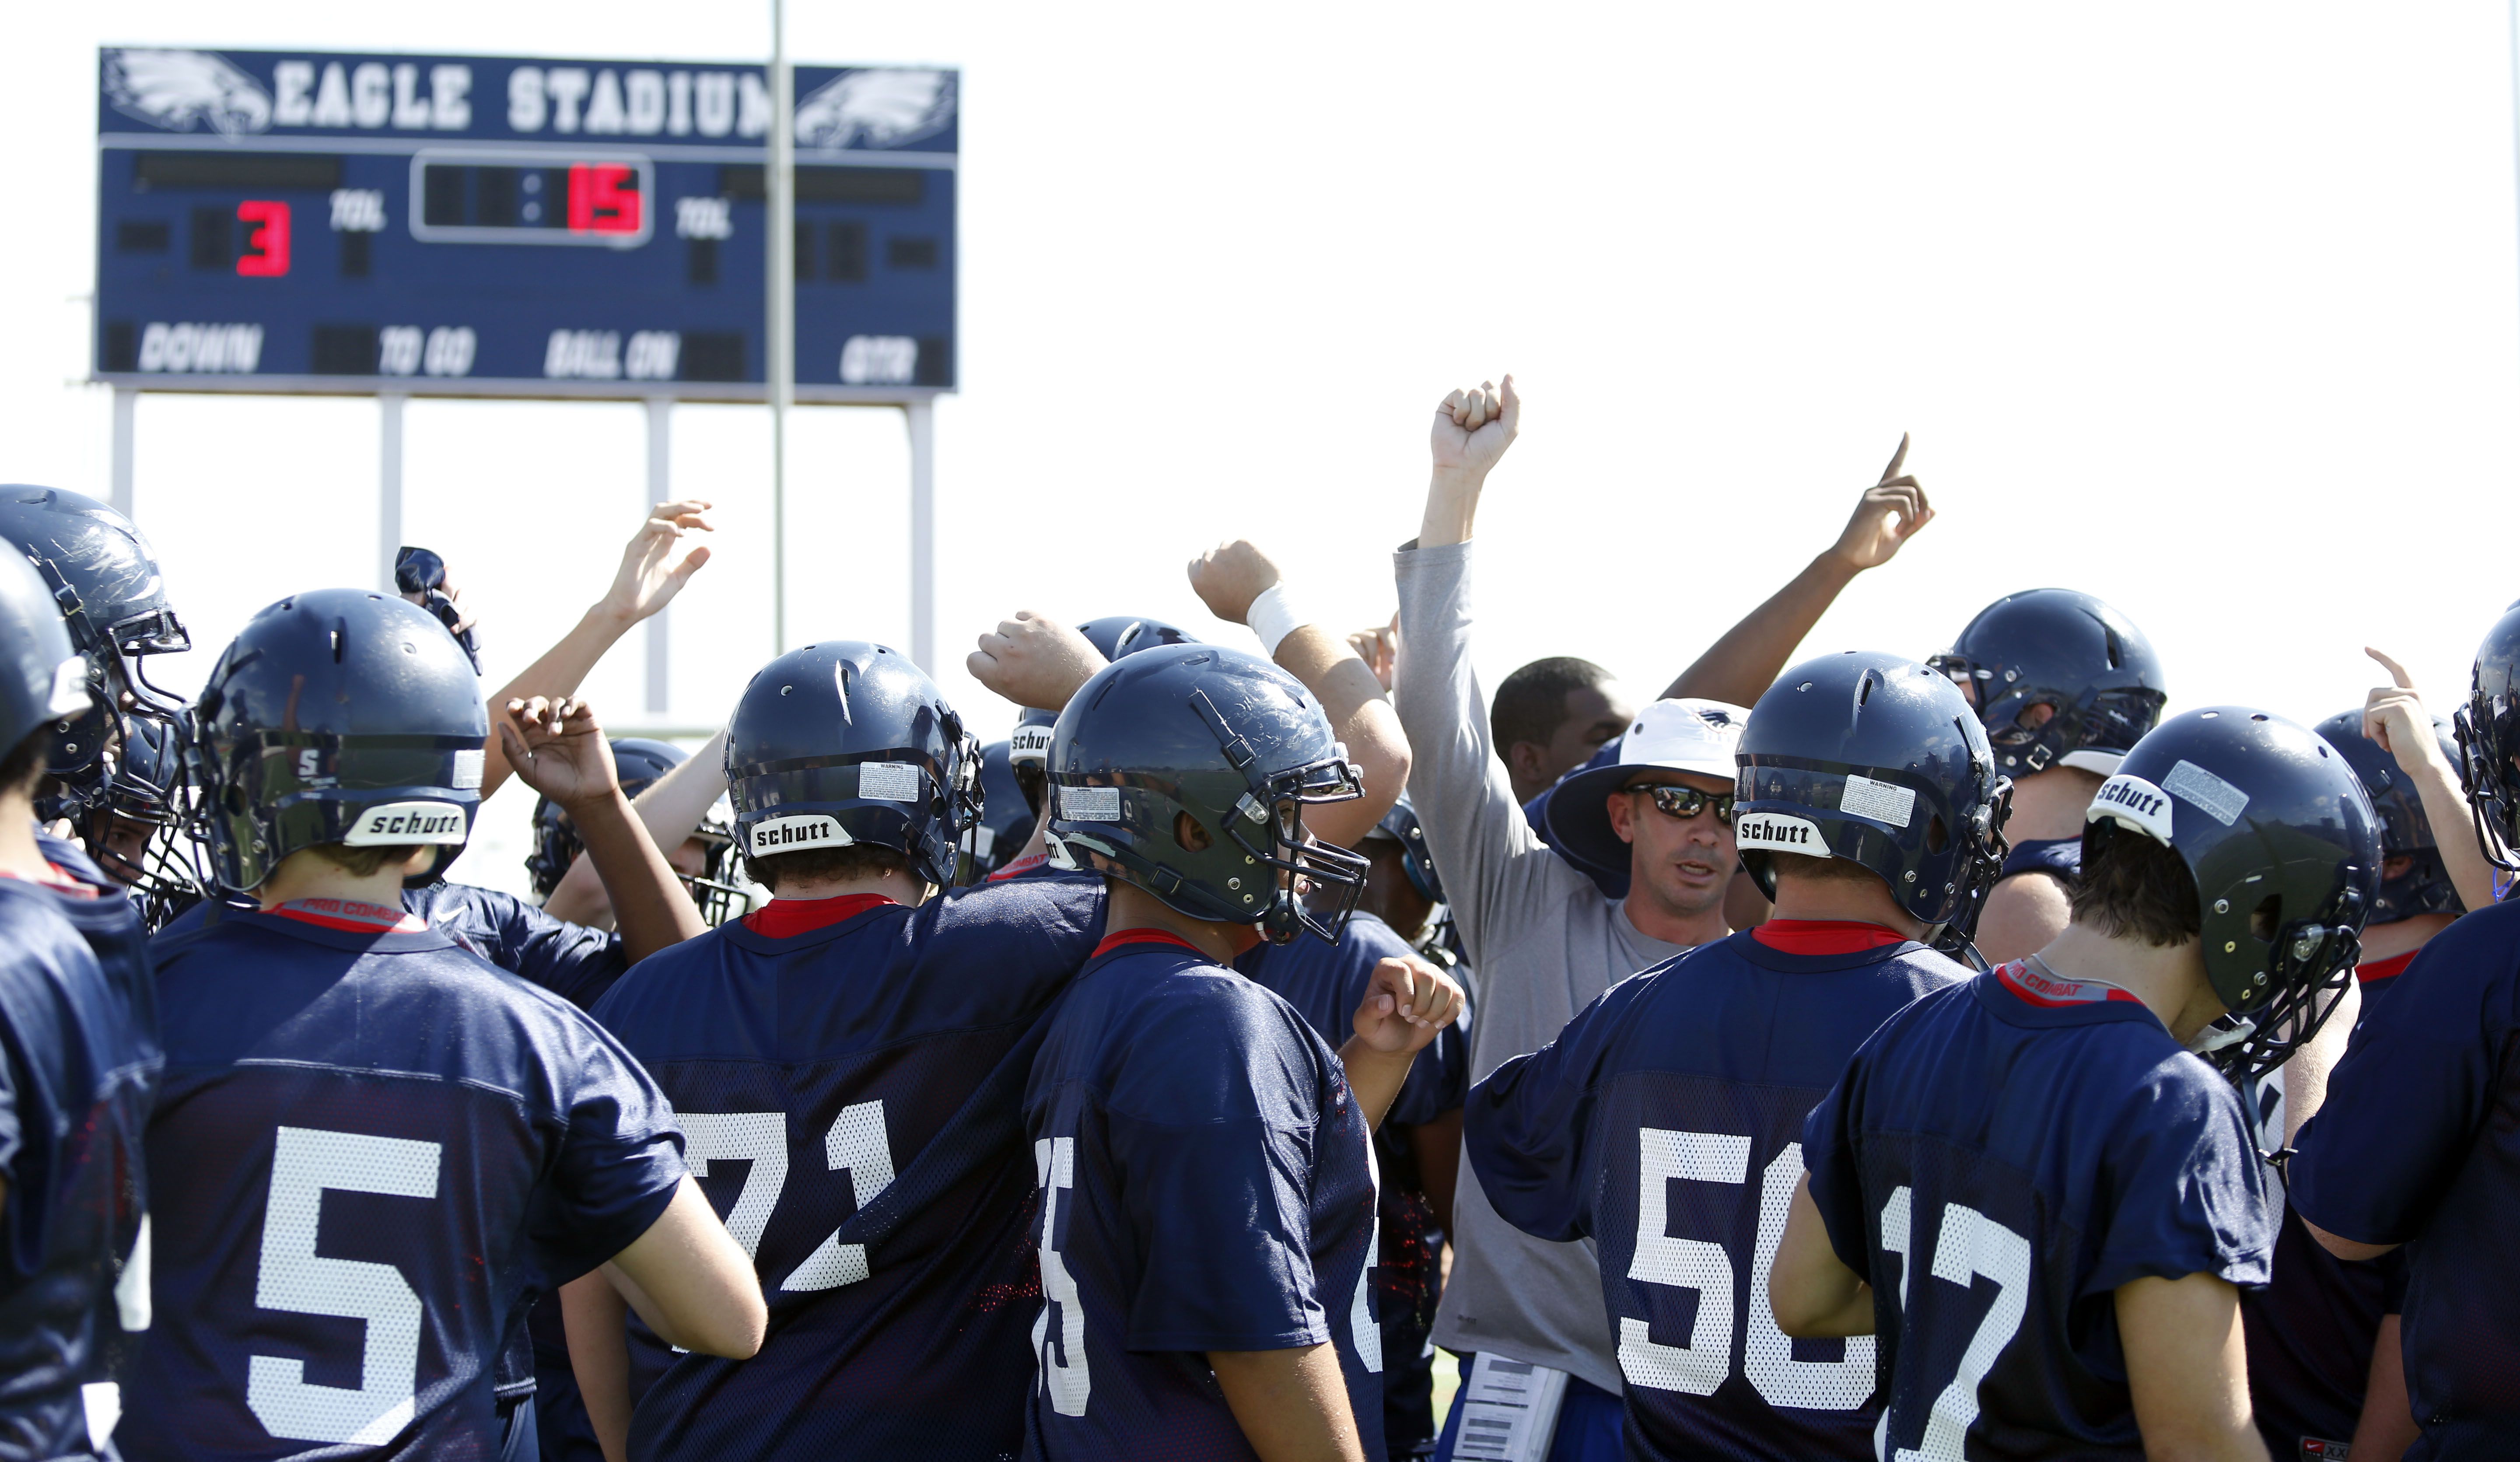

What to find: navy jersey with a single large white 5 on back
left=119, top=910, right=683, bottom=1459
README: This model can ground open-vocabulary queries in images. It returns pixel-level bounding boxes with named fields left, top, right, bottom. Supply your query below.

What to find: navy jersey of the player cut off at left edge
left=0, top=862, right=159, bottom=1462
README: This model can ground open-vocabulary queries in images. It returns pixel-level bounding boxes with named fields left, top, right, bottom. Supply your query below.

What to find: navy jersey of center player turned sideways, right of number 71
left=1023, top=930, right=1383, bottom=1462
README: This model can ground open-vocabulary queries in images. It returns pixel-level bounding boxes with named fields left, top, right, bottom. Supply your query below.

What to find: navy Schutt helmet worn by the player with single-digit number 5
left=192, top=590, right=489, bottom=895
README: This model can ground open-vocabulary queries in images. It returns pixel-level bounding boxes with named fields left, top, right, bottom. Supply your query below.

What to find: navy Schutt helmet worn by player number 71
left=726, top=640, right=980, bottom=887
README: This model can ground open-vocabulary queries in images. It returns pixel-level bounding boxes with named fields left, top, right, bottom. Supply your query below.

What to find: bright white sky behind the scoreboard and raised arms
left=0, top=0, right=2520, bottom=887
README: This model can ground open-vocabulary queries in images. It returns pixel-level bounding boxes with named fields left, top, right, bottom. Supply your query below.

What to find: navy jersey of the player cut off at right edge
left=2291, top=905, right=2520, bottom=1457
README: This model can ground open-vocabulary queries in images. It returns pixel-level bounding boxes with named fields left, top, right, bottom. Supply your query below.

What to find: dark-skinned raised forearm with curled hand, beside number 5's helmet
left=497, top=696, right=708, bottom=963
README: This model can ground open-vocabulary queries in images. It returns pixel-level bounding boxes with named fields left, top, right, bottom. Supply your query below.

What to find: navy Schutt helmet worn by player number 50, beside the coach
left=1734, top=651, right=2013, bottom=963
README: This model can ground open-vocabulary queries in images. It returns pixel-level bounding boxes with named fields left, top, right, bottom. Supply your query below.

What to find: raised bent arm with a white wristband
left=1190, top=539, right=1409, bottom=847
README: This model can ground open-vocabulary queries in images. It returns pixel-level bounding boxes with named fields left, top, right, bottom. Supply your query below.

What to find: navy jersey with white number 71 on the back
left=595, top=874, right=1104, bottom=1462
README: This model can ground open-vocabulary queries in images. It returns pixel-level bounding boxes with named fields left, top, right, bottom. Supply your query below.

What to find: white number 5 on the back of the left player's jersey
left=245, top=1127, right=438, bottom=1447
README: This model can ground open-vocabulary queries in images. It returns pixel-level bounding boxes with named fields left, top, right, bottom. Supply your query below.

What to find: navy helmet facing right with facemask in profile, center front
left=1048, top=645, right=1366, bottom=945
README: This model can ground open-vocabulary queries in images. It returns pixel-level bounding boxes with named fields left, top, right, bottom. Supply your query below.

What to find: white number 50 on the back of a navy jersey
left=1618, top=1127, right=1872, bottom=1412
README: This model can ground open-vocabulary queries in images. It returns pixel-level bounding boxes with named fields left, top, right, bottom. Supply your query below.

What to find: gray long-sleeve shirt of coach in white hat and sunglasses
left=1393, top=545, right=1684, bottom=1392
